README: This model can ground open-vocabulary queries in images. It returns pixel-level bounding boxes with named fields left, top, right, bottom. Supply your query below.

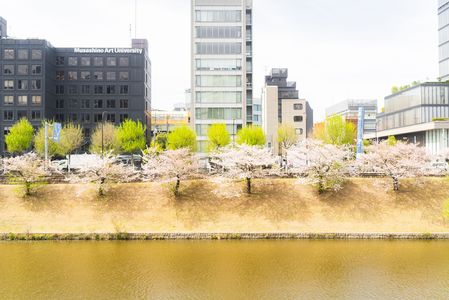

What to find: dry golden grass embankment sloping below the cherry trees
left=0, top=178, right=449, bottom=233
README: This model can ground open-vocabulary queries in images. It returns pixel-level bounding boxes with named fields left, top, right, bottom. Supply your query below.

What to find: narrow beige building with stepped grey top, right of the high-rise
left=262, top=69, right=313, bottom=154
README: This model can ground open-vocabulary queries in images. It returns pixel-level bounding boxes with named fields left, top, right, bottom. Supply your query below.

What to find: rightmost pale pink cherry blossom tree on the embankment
left=357, top=141, right=428, bottom=191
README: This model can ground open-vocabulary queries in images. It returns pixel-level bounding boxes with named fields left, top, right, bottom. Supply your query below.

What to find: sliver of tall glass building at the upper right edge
left=438, top=0, right=449, bottom=81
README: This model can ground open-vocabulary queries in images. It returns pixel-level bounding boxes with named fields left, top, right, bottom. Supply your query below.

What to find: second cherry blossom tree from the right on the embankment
left=287, top=139, right=353, bottom=194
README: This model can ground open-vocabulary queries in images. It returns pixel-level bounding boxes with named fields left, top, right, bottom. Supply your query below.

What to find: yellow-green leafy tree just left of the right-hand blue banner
left=316, top=115, right=357, bottom=146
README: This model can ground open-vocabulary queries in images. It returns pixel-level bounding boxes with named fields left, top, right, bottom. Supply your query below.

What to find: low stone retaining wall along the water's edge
left=0, top=232, right=449, bottom=241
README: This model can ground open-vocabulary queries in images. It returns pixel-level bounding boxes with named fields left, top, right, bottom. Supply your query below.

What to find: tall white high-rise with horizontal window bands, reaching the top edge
left=191, top=0, right=253, bottom=152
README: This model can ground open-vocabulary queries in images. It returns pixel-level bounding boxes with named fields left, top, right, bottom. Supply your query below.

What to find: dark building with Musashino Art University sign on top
left=0, top=18, right=151, bottom=153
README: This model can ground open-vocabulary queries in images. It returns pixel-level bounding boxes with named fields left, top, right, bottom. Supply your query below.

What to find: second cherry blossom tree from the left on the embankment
left=74, top=154, right=138, bottom=196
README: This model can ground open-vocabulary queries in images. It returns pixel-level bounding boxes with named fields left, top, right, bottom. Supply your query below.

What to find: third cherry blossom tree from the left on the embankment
left=142, top=148, right=198, bottom=196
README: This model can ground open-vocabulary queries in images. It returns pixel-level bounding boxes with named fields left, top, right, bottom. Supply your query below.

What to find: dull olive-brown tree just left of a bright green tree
left=90, top=123, right=120, bottom=154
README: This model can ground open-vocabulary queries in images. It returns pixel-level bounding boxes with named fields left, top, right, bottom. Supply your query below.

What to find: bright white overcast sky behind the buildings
left=0, top=0, right=438, bottom=121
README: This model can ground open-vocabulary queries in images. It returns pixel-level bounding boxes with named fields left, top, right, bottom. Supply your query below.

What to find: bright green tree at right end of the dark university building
left=117, top=119, right=146, bottom=164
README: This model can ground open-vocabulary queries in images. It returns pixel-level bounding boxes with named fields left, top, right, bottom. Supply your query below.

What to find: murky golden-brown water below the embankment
left=0, top=241, right=449, bottom=299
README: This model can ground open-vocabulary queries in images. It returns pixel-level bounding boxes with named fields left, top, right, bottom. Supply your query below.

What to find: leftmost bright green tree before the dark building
left=5, top=118, right=34, bottom=153
